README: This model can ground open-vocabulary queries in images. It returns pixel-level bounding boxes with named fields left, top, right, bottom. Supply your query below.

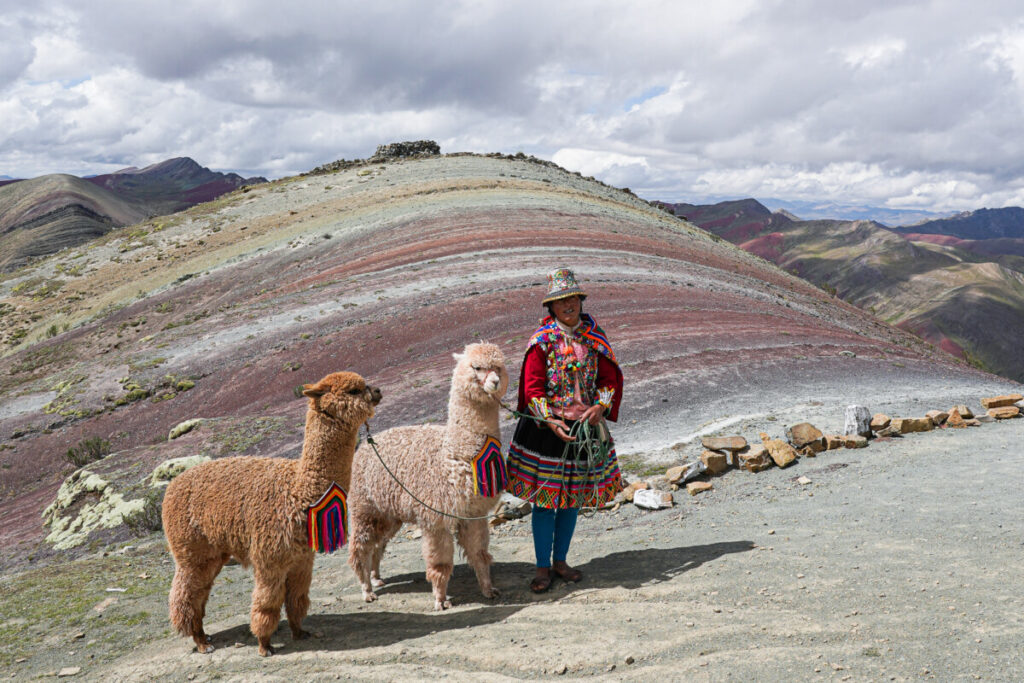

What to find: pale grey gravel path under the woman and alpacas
left=66, top=403, right=1024, bottom=681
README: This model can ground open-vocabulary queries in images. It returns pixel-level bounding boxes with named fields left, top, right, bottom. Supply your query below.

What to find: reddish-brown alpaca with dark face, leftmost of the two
left=163, top=373, right=381, bottom=656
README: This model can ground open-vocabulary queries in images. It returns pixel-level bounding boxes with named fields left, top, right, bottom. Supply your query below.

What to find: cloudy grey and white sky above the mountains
left=0, top=0, right=1024, bottom=211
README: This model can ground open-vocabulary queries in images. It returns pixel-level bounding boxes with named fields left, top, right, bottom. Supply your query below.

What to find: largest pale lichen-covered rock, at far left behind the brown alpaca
left=43, top=469, right=145, bottom=550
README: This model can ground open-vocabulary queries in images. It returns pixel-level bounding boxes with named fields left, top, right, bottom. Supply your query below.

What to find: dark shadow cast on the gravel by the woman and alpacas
left=213, top=541, right=755, bottom=651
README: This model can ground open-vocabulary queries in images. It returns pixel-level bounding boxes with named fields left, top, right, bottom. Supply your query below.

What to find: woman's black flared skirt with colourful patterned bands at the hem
left=506, top=418, right=623, bottom=509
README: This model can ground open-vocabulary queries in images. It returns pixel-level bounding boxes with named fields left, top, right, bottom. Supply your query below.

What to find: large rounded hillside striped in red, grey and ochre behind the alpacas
left=0, top=155, right=1009, bottom=563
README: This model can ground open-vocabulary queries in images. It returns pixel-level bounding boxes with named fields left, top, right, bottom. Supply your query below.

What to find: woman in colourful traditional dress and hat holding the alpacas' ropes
left=508, top=268, right=623, bottom=593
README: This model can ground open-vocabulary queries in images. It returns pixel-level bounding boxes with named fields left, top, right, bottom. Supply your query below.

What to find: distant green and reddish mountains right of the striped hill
left=665, top=199, right=1024, bottom=381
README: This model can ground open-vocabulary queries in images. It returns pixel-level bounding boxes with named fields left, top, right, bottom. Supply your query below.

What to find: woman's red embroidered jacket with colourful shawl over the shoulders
left=518, top=313, right=623, bottom=421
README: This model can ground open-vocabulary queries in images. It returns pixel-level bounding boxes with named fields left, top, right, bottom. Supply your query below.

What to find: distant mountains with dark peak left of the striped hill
left=0, top=157, right=266, bottom=271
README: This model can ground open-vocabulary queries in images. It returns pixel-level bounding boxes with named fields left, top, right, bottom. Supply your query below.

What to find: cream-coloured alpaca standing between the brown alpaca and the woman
left=348, top=344, right=509, bottom=609
